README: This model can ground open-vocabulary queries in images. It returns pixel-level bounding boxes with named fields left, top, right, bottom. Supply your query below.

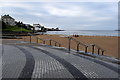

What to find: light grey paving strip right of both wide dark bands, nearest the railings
left=35, top=47, right=118, bottom=78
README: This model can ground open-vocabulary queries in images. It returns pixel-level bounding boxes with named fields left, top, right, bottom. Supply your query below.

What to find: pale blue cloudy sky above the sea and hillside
left=0, top=2, right=118, bottom=30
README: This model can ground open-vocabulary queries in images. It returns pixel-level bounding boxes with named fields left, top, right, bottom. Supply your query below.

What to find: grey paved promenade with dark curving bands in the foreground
left=0, top=41, right=120, bottom=80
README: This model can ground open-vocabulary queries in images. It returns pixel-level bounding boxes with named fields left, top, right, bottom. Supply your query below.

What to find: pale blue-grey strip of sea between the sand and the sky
left=45, top=30, right=120, bottom=36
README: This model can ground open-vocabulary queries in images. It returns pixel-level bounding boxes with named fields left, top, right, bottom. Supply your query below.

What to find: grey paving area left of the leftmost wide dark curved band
left=2, top=45, right=26, bottom=78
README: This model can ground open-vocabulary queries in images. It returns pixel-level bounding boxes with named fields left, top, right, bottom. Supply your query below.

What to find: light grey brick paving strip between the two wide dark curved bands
left=22, top=47, right=73, bottom=78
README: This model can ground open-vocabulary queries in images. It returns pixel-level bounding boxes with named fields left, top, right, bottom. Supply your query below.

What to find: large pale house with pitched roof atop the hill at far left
left=1, top=15, right=16, bottom=26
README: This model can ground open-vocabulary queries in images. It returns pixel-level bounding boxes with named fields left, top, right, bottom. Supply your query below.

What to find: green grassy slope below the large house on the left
left=2, top=26, right=31, bottom=32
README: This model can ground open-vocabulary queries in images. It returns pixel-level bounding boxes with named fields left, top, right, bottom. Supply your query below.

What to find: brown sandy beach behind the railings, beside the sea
left=19, top=34, right=120, bottom=58
